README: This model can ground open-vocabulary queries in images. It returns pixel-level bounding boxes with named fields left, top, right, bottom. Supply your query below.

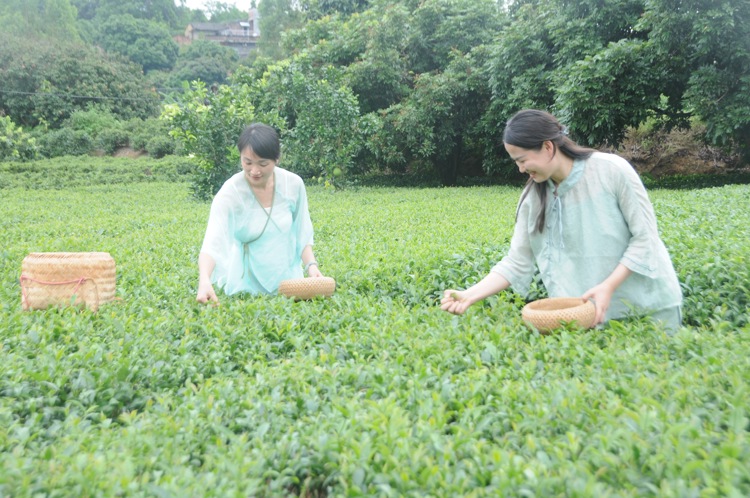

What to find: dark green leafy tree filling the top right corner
left=641, top=0, right=750, bottom=162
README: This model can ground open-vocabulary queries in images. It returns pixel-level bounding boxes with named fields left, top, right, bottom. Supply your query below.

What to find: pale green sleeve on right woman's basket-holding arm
left=616, top=160, right=660, bottom=278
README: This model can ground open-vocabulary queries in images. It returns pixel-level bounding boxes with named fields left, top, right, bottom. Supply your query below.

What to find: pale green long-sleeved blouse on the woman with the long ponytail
left=492, top=152, right=682, bottom=320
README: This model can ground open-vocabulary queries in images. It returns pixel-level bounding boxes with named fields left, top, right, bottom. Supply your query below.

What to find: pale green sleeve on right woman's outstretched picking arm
left=491, top=196, right=534, bottom=295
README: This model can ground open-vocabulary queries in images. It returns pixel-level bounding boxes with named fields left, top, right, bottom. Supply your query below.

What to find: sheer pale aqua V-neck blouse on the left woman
left=201, top=166, right=313, bottom=294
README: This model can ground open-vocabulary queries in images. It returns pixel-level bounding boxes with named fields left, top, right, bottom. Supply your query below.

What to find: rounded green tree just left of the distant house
left=96, top=14, right=179, bottom=71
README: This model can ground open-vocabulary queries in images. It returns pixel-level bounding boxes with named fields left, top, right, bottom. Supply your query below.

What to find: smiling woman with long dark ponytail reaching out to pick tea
left=441, top=110, right=682, bottom=331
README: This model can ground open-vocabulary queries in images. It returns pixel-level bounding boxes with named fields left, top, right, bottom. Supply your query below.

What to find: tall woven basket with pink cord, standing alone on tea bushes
left=21, top=252, right=115, bottom=311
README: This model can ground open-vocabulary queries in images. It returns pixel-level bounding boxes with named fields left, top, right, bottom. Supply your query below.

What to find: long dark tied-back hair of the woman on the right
left=503, top=109, right=595, bottom=233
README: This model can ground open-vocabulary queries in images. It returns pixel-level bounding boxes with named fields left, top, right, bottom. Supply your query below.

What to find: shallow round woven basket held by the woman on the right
left=521, top=297, right=596, bottom=334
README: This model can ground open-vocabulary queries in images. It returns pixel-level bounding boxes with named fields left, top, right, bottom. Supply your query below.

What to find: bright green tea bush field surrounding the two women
left=0, top=162, right=750, bottom=498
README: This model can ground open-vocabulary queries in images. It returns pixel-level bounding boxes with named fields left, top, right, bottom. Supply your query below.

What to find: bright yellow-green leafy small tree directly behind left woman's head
left=162, top=81, right=282, bottom=200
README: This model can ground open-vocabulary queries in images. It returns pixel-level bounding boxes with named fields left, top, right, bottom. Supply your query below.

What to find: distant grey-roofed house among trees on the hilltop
left=181, top=9, right=260, bottom=58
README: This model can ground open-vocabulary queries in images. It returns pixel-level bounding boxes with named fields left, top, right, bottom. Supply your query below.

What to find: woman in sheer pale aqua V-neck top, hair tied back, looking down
left=197, top=123, right=323, bottom=303
